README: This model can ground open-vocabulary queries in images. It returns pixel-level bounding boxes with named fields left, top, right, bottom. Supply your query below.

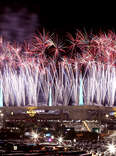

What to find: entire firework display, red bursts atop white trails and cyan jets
left=0, top=30, right=116, bottom=106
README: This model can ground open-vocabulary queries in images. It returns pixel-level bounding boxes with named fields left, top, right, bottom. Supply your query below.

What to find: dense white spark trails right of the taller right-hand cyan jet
left=84, top=64, right=116, bottom=106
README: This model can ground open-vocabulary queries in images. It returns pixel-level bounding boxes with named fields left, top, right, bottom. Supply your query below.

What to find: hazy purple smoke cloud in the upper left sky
left=0, top=7, right=39, bottom=42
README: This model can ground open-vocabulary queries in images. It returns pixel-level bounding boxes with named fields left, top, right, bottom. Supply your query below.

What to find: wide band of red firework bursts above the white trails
left=0, top=29, right=116, bottom=70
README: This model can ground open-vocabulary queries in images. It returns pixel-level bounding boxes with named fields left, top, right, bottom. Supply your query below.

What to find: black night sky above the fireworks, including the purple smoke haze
left=0, top=0, right=116, bottom=41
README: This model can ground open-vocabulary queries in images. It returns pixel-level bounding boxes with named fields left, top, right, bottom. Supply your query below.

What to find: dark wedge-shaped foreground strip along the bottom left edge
left=0, top=141, right=91, bottom=156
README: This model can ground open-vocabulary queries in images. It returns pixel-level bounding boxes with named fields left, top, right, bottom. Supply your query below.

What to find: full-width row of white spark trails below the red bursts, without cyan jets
left=1, top=60, right=116, bottom=106
